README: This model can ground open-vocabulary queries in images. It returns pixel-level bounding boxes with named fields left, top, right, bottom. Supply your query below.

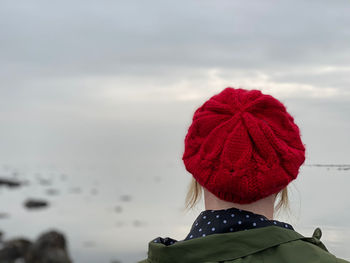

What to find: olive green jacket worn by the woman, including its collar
left=139, top=226, right=349, bottom=263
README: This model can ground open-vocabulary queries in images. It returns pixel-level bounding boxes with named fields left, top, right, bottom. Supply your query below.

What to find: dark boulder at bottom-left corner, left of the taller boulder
left=0, top=238, right=32, bottom=263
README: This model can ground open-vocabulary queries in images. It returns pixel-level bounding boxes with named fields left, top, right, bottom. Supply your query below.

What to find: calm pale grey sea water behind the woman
left=0, top=164, right=350, bottom=263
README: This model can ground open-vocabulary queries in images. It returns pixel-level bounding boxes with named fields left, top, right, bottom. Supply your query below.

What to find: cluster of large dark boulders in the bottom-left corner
left=0, top=231, right=72, bottom=263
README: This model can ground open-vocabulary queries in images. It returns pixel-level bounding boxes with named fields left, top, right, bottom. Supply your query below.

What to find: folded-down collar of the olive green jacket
left=148, top=226, right=308, bottom=263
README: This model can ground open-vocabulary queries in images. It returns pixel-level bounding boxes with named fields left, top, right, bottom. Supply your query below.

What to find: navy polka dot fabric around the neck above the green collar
left=153, top=208, right=294, bottom=246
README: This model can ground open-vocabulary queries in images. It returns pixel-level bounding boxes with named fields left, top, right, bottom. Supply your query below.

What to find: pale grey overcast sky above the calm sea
left=0, top=0, right=350, bottom=167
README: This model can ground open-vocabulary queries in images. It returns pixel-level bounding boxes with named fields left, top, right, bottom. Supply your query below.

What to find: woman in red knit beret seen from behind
left=137, top=88, right=347, bottom=263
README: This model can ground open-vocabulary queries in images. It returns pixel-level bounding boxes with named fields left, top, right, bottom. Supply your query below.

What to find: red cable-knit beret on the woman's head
left=182, top=87, right=305, bottom=204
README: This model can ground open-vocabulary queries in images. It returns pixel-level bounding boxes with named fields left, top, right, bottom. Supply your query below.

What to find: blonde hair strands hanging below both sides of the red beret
left=185, top=177, right=289, bottom=211
